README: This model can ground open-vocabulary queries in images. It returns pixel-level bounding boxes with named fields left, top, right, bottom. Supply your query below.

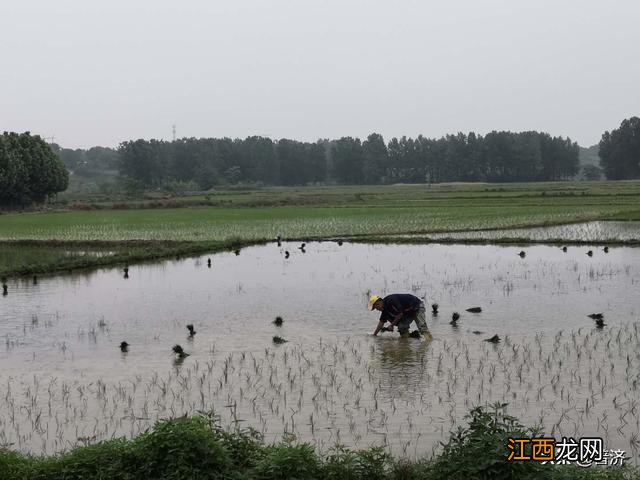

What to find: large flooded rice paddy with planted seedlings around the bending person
left=0, top=242, right=640, bottom=461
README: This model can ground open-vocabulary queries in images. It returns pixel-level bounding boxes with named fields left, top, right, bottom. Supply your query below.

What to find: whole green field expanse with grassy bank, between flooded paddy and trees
left=0, top=182, right=640, bottom=276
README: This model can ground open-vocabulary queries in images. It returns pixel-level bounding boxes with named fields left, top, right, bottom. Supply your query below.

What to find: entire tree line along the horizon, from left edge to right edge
left=0, top=117, right=640, bottom=206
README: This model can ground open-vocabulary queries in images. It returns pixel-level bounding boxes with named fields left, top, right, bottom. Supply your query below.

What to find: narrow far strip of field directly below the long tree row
left=59, top=181, right=640, bottom=208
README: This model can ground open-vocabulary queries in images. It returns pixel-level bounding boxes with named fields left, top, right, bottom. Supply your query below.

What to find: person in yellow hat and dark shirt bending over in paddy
left=369, top=293, right=433, bottom=340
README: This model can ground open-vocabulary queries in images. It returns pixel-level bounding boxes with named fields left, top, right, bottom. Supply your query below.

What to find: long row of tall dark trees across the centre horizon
left=118, top=132, right=579, bottom=189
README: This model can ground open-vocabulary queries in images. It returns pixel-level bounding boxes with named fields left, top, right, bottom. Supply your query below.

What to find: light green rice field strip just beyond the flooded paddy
left=0, top=202, right=638, bottom=241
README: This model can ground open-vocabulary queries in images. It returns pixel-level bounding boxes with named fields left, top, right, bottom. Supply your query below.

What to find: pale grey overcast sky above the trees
left=0, top=0, right=640, bottom=148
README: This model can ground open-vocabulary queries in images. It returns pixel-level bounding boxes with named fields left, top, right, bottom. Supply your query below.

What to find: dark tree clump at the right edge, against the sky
left=600, top=117, right=640, bottom=180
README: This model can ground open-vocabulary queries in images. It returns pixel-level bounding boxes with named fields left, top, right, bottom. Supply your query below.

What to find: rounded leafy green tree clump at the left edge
left=0, top=132, right=69, bottom=206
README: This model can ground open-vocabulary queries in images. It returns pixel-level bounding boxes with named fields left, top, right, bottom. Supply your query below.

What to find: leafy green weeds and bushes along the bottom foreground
left=0, top=405, right=640, bottom=480
